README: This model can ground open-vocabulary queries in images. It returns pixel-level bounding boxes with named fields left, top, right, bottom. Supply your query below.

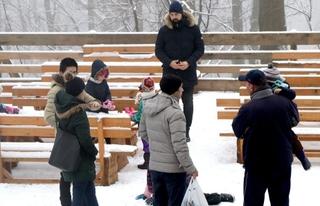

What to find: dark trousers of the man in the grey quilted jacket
left=150, top=171, right=186, bottom=206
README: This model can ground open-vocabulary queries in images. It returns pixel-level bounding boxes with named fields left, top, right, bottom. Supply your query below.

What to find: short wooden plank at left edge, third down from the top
left=0, top=64, right=41, bottom=74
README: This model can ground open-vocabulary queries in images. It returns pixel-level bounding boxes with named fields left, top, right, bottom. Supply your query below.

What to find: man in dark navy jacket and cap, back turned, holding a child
left=232, top=70, right=298, bottom=206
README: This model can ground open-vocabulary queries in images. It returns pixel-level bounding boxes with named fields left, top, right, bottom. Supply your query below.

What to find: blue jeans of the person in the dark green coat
left=72, top=181, right=98, bottom=206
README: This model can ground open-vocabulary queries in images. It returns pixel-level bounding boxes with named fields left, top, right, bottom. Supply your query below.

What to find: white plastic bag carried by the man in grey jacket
left=181, top=178, right=209, bottom=206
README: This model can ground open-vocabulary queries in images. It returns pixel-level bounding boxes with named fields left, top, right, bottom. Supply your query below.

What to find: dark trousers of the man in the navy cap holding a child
left=243, top=167, right=291, bottom=206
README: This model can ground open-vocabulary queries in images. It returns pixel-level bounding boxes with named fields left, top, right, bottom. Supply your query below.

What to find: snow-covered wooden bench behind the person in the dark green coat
left=0, top=114, right=137, bottom=185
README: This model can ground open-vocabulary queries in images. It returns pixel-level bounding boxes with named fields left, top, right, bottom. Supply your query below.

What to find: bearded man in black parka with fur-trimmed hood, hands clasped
left=155, top=1, right=204, bottom=141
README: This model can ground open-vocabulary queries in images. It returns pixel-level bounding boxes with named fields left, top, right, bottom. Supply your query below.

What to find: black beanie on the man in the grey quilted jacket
left=160, top=74, right=182, bottom=95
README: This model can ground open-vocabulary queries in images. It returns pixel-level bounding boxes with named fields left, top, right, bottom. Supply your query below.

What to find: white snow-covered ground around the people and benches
left=0, top=92, right=320, bottom=206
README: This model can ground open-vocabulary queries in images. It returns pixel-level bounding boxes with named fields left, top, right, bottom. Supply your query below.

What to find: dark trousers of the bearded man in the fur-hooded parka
left=181, top=87, right=193, bottom=132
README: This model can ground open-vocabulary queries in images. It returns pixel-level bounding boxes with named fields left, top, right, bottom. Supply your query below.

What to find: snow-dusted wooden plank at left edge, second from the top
left=0, top=50, right=82, bottom=60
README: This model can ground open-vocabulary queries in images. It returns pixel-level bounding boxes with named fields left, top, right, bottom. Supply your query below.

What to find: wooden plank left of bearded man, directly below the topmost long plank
left=82, top=44, right=154, bottom=54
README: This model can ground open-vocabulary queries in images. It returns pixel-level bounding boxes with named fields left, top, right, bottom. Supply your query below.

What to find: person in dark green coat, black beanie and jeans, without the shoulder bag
left=55, top=73, right=98, bottom=206
